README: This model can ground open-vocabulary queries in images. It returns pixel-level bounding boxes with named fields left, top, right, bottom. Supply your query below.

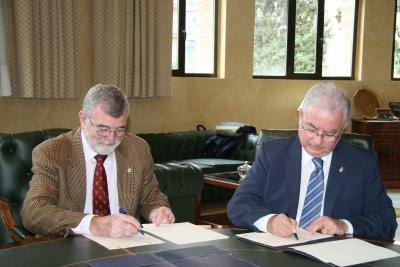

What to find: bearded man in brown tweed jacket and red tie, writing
left=21, top=84, right=175, bottom=238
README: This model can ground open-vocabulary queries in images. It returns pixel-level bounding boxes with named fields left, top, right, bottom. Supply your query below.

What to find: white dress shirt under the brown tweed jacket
left=71, top=132, right=119, bottom=234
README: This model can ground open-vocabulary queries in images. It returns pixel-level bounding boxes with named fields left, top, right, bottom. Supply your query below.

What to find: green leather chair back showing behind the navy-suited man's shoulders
left=256, top=129, right=372, bottom=154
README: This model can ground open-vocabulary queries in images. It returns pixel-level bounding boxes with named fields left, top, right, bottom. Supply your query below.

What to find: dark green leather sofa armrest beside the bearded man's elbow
left=154, top=162, right=204, bottom=223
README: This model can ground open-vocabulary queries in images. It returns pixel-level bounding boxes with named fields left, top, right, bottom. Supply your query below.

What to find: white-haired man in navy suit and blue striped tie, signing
left=227, top=83, right=397, bottom=239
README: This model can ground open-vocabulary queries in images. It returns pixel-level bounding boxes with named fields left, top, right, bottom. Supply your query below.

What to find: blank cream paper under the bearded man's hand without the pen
left=143, top=222, right=229, bottom=245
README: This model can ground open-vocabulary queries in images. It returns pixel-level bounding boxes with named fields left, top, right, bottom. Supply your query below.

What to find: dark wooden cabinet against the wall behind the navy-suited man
left=352, top=119, right=400, bottom=188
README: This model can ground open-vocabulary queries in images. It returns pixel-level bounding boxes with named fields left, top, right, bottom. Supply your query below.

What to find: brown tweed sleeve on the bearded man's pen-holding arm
left=21, top=145, right=85, bottom=239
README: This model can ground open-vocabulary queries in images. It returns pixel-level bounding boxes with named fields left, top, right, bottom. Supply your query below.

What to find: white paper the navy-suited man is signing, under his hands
left=236, top=228, right=332, bottom=247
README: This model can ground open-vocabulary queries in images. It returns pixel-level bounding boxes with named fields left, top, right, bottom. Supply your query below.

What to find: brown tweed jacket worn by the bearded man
left=21, top=128, right=169, bottom=236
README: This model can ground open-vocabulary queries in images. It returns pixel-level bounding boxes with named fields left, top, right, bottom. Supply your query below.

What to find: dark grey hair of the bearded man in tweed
left=82, top=84, right=129, bottom=118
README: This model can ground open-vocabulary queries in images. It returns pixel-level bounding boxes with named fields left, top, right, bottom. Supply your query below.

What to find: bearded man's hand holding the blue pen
left=89, top=213, right=142, bottom=238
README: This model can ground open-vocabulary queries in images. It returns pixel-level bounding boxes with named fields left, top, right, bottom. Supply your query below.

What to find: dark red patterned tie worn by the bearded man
left=93, top=155, right=110, bottom=216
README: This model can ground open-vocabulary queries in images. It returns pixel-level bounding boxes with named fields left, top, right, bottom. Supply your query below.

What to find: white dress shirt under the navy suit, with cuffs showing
left=253, top=147, right=353, bottom=234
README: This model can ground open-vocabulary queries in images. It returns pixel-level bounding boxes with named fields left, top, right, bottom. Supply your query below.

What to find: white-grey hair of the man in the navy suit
left=302, top=83, right=351, bottom=125
